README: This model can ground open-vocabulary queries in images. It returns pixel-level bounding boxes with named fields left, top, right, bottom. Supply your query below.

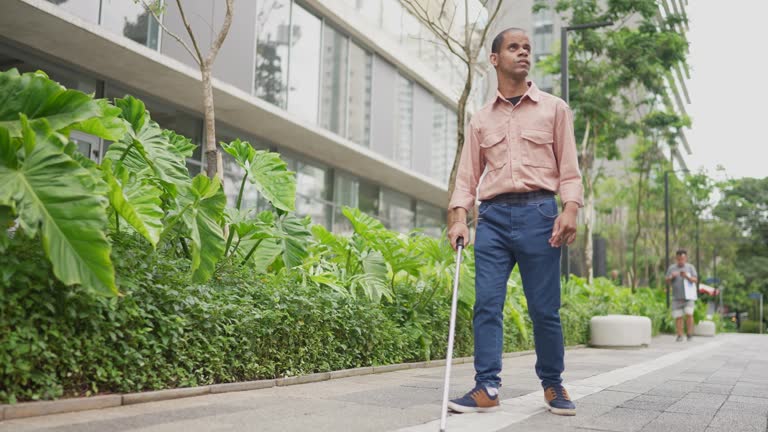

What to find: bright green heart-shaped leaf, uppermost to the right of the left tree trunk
left=221, top=139, right=296, bottom=211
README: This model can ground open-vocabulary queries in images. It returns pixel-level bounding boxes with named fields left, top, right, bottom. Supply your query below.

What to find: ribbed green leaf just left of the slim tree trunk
left=106, top=96, right=189, bottom=196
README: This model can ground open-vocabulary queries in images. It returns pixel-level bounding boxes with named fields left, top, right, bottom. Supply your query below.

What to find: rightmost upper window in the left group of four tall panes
left=347, top=43, right=373, bottom=147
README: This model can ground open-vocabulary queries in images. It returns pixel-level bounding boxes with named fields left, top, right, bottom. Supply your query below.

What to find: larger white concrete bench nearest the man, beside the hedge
left=589, top=315, right=651, bottom=348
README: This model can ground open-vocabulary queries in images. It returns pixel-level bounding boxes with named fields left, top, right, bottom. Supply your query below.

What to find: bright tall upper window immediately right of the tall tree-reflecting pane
left=288, top=4, right=322, bottom=124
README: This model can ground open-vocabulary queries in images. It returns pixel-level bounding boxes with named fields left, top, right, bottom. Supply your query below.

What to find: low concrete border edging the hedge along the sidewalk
left=0, top=345, right=585, bottom=421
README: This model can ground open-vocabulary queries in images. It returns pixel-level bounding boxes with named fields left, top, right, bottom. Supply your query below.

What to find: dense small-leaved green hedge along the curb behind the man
left=0, top=236, right=667, bottom=403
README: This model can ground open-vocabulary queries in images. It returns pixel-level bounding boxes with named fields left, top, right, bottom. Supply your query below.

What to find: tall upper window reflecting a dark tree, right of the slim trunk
left=254, top=0, right=291, bottom=108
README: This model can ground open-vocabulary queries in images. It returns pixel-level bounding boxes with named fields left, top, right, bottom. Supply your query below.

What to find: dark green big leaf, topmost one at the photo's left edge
left=0, top=69, right=125, bottom=140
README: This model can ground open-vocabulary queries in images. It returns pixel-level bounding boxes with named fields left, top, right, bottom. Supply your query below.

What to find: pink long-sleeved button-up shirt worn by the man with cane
left=448, top=82, right=584, bottom=211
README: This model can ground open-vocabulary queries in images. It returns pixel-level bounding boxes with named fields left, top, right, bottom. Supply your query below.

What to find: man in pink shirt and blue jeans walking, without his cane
left=448, top=28, right=583, bottom=415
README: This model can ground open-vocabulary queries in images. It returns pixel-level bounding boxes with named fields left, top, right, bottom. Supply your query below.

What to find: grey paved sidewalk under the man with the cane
left=0, top=334, right=768, bottom=432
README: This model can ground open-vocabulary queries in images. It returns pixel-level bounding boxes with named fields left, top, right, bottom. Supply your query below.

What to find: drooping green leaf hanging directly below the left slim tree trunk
left=179, top=174, right=227, bottom=282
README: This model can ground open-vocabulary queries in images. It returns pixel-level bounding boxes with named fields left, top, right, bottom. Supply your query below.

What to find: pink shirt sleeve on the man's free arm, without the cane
left=554, top=102, right=584, bottom=207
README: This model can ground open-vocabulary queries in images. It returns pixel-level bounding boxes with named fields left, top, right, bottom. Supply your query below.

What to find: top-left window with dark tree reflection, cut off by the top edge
left=100, top=0, right=160, bottom=50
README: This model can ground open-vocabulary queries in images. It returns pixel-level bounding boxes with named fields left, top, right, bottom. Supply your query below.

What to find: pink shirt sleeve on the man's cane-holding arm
left=448, top=122, right=485, bottom=212
